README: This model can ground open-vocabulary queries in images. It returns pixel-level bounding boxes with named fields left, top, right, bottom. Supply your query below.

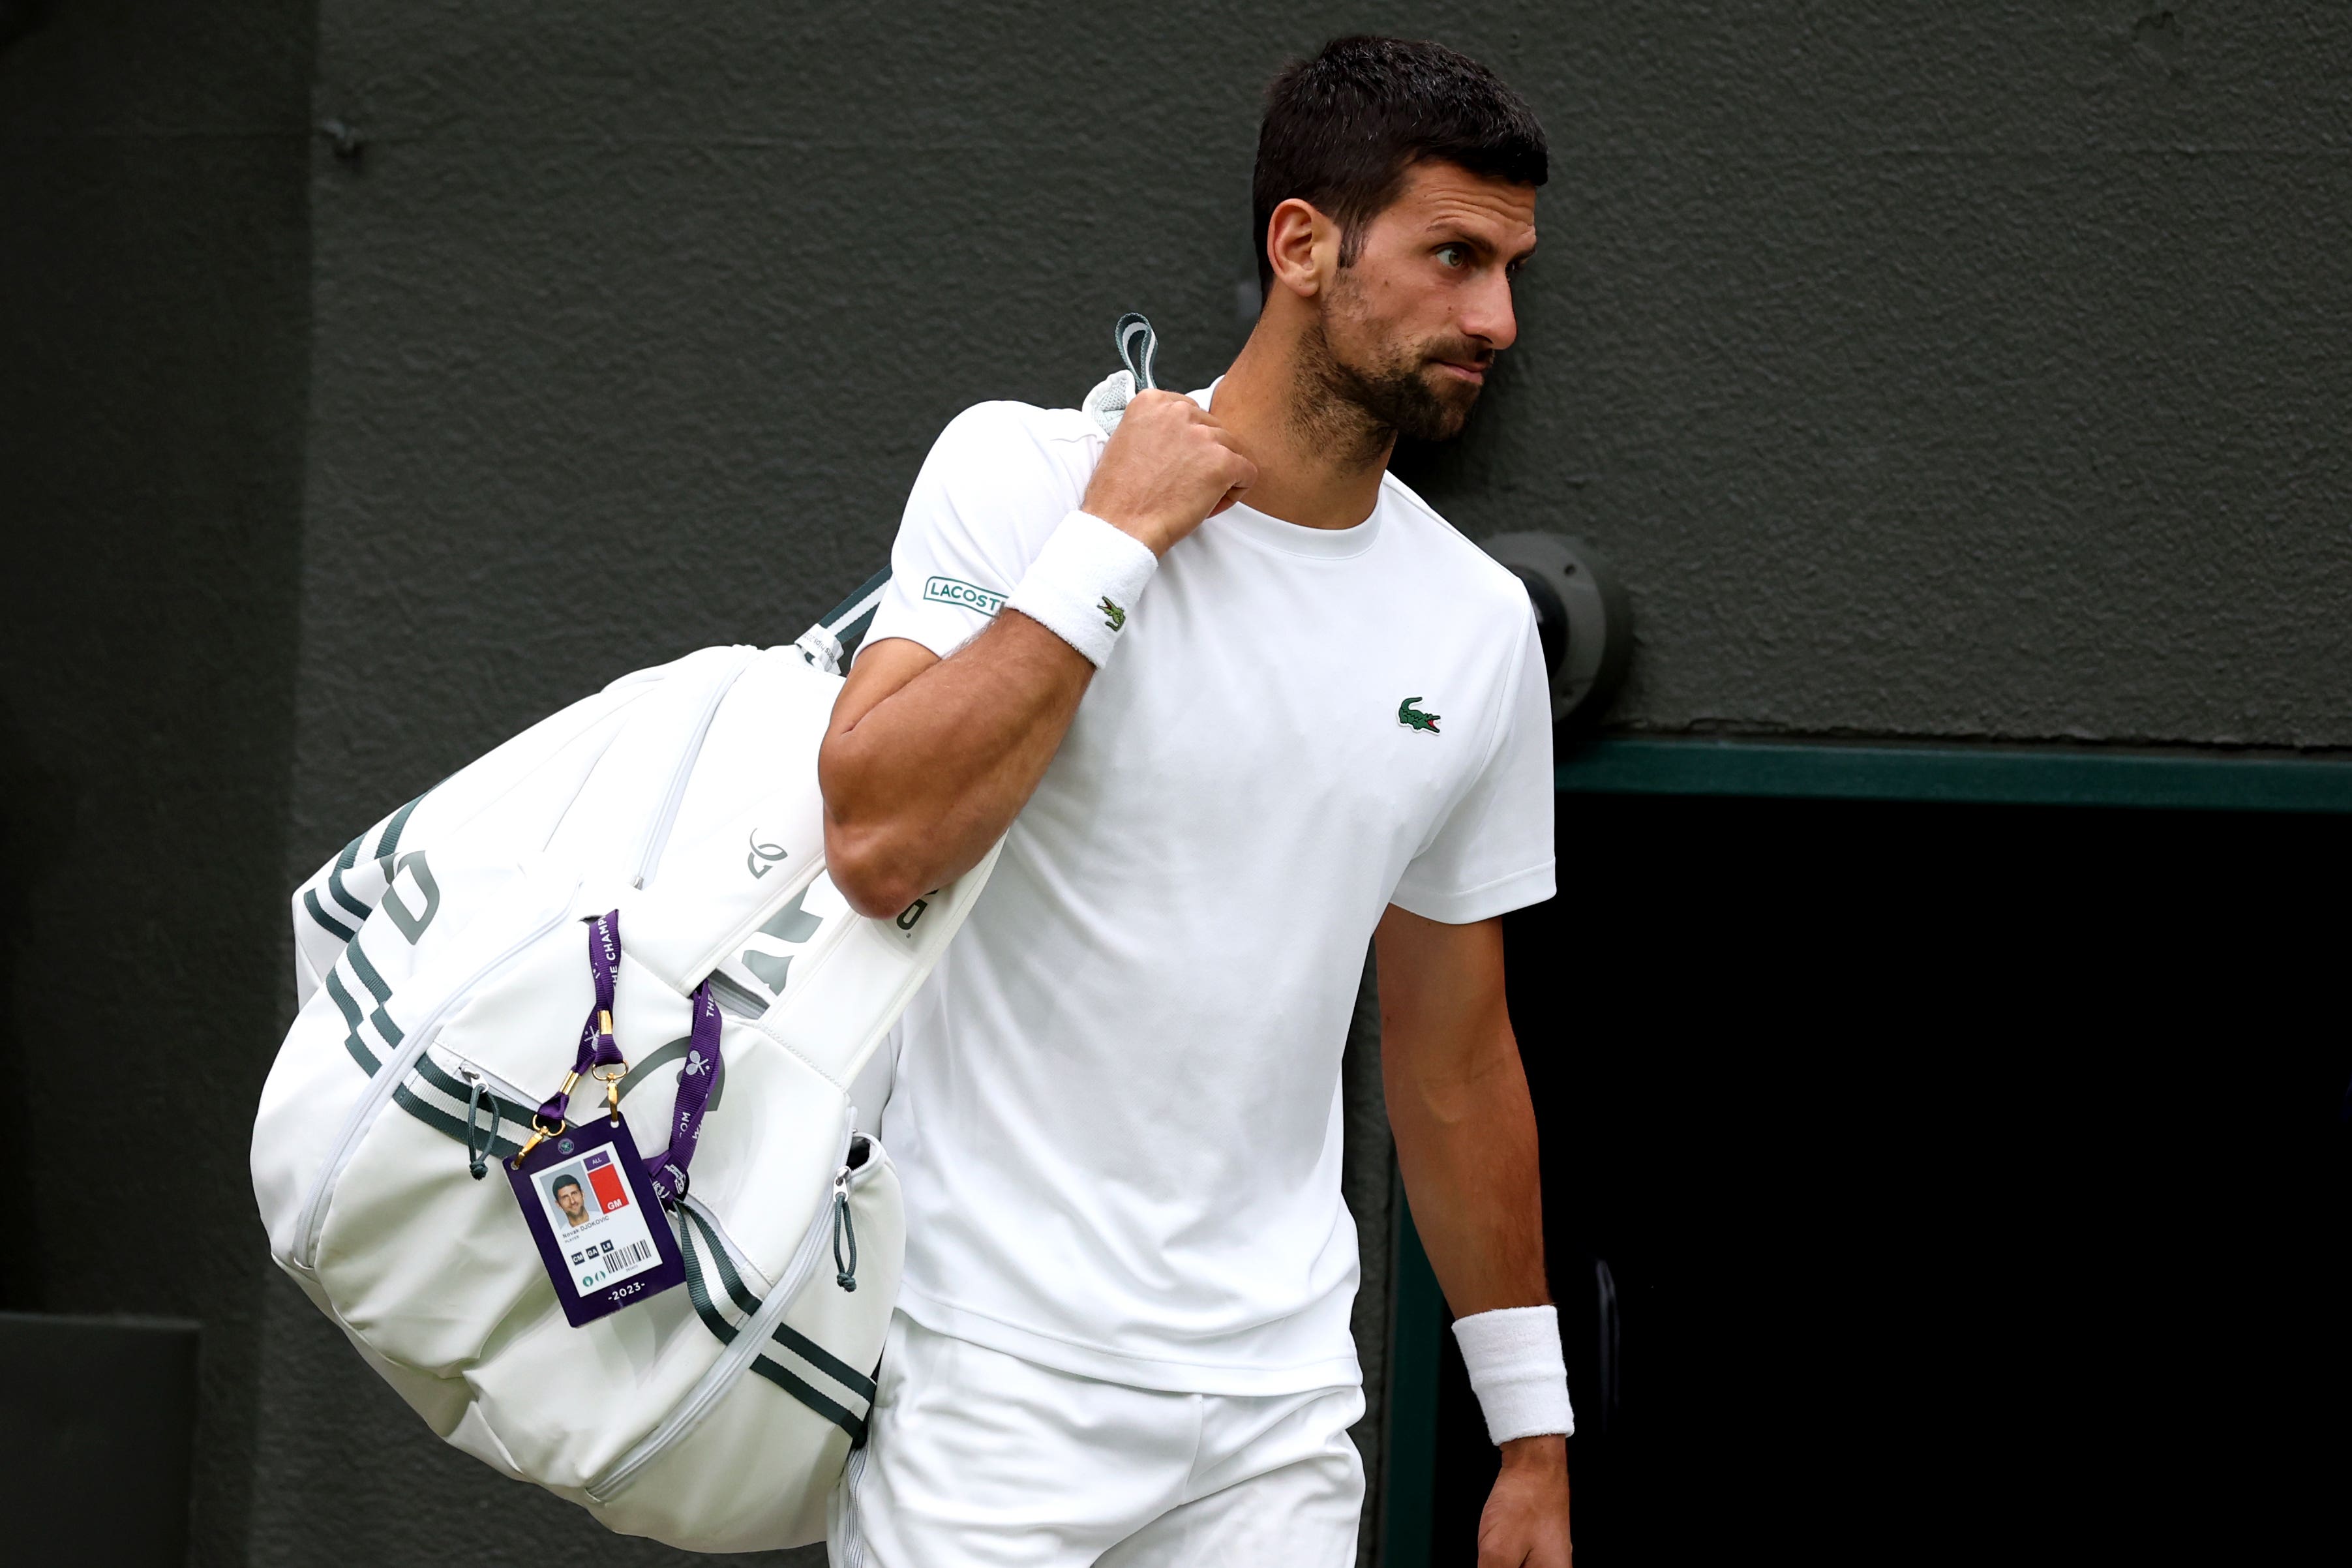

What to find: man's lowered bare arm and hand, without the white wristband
left=1374, top=905, right=1569, bottom=1568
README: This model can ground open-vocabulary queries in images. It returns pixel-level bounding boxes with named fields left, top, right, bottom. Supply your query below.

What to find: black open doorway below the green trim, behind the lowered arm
left=1432, top=794, right=2352, bottom=1568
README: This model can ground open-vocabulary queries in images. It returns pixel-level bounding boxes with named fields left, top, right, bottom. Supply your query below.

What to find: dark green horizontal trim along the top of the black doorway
left=1555, top=736, right=2352, bottom=811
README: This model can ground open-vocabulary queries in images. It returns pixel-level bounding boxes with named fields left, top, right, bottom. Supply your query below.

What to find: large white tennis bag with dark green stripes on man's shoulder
left=252, top=573, right=995, bottom=1552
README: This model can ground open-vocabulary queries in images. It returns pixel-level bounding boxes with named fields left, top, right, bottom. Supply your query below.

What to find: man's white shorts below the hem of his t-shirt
left=826, top=1312, right=1364, bottom=1568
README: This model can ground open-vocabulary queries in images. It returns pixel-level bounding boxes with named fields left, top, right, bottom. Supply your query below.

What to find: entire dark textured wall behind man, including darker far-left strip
left=14, top=0, right=2352, bottom=1563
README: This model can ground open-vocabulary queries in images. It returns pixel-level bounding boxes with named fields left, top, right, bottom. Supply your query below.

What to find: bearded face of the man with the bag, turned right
left=1322, top=162, right=1536, bottom=440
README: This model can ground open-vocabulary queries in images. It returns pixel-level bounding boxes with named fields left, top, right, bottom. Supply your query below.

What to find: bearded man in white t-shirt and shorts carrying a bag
left=819, top=38, right=1571, bottom=1568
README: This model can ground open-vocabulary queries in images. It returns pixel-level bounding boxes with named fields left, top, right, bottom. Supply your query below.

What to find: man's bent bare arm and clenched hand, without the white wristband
left=816, top=393, right=1258, bottom=917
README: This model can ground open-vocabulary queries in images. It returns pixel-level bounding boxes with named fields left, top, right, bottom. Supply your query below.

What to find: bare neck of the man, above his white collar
left=1214, top=308, right=1395, bottom=529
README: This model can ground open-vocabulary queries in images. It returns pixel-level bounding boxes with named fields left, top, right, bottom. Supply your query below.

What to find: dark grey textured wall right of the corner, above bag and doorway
left=280, top=0, right=2352, bottom=822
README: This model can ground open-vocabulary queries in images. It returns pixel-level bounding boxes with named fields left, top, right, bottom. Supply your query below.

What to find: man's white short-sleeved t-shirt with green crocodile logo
left=868, top=393, right=1552, bottom=1394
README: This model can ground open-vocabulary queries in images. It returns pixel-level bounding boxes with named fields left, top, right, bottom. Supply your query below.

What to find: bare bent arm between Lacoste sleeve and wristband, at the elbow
left=816, top=611, right=1094, bottom=914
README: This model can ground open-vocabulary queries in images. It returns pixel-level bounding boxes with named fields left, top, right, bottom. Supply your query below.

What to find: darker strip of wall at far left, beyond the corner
left=0, top=0, right=313, bottom=1563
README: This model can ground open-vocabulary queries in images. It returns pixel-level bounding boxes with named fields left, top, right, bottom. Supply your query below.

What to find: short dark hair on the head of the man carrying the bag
left=1249, top=35, right=1550, bottom=289
